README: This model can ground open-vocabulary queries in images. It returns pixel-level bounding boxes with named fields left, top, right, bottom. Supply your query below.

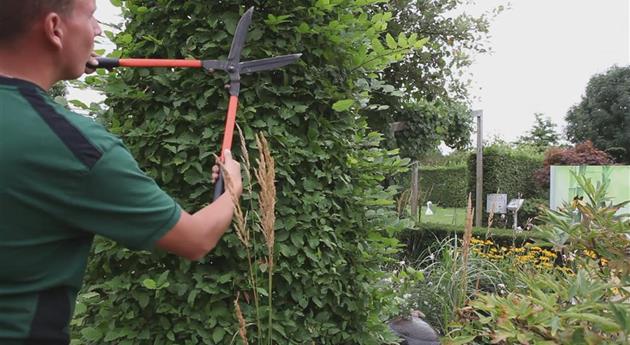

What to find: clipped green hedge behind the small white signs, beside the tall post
left=468, top=146, right=549, bottom=213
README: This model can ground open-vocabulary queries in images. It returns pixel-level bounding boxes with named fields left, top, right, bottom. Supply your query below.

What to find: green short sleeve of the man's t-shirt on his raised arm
left=71, top=143, right=181, bottom=249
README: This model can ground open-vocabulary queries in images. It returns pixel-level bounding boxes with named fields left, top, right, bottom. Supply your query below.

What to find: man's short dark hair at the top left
left=0, top=0, right=75, bottom=44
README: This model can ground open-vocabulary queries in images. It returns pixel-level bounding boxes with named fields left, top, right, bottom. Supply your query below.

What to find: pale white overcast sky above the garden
left=85, top=0, right=630, bottom=141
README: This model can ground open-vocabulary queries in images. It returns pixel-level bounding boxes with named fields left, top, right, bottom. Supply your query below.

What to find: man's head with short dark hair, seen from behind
left=0, top=0, right=101, bottom=79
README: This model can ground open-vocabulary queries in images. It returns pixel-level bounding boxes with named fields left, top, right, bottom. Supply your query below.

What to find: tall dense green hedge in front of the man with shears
left=73, top=0, right=422, bottom=345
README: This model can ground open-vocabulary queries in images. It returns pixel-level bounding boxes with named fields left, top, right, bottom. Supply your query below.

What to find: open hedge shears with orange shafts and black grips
left=90, top=7, right=302, bottom=200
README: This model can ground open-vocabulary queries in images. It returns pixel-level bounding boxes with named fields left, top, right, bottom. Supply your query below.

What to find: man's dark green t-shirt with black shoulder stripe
left=0, top=77, right=181, bottom=345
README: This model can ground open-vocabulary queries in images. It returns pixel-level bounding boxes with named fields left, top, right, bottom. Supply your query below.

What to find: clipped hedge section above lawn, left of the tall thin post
left=419, top=164, right=468, bottom=207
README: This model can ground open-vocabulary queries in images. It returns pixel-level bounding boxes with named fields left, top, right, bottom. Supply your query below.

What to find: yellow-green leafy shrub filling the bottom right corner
left=444, top=176, right=630, bottom=344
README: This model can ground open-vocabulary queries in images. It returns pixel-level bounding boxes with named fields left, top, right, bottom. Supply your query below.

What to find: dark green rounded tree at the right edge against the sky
left=565, top=66, right=630, bottom=163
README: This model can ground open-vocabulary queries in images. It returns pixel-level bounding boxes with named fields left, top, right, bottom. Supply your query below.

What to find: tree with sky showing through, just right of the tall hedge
left=367, top=0, right=500, bottom=157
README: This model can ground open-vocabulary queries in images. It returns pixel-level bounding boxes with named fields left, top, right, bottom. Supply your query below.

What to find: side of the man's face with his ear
left=61, top=0, right=101, bottom=79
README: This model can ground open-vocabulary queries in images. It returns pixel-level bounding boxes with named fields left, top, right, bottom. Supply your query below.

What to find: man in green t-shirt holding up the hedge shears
left=0, top=0, right=242, bottom=345
